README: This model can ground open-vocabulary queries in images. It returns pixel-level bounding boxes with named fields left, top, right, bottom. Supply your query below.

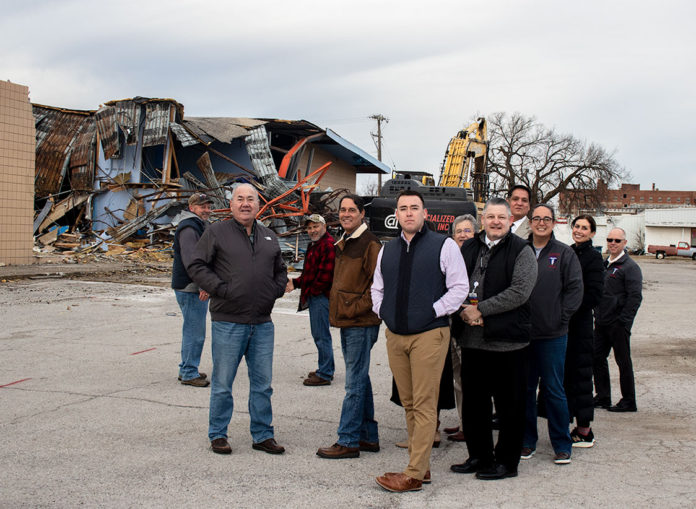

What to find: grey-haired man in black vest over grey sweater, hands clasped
left=450, top=198, right=537, bottom=480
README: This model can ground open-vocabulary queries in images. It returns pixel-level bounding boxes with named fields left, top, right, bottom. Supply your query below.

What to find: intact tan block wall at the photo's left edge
left=0, top=81, right=36, bottom=264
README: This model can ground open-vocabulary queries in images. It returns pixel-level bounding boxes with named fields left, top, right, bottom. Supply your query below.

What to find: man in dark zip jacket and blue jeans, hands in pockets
left=187, top=184, right=287, bottom=454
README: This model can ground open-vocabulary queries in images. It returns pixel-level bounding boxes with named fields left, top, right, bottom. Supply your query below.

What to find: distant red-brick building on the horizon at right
left=559, top=179, right=696, bottom=215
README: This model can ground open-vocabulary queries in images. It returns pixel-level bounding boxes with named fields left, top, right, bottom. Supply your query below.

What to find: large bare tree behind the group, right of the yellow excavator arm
left=488, top=112, right=629, bottom=209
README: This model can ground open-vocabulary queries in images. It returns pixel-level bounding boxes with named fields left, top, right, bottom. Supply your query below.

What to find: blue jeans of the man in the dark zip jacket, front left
left=208, top=321, right=274, bottom=443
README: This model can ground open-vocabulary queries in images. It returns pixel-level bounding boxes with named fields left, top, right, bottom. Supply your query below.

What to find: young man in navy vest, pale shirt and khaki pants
left=372, top=190, right=469, bottom=492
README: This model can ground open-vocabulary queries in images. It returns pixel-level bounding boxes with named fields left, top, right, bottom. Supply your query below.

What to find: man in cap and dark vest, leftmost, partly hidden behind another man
left=172, top=193, right=213, bottom=387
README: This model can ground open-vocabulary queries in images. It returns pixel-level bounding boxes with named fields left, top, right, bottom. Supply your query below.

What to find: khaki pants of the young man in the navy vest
left=386, top=327, right=450, bottom=481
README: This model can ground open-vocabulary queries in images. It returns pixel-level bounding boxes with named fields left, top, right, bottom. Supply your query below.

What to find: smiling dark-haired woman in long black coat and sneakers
left=564, top=214, right=604, bottom=447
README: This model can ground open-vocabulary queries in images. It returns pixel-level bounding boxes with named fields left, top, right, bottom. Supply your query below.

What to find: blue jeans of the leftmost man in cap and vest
left=174, top=290, right=208, bottom=380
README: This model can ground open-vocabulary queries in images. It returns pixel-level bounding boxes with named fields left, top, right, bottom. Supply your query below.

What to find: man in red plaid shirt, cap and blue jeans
left=286, top=214, right=336, bottom=386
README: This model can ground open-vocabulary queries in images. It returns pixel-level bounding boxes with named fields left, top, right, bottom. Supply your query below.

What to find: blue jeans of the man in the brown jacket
left=338, top=325, right=379, bottom=447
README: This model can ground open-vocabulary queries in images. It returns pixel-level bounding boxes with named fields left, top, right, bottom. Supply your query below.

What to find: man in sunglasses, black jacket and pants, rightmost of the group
left=593, top=228, right=643, bottom=412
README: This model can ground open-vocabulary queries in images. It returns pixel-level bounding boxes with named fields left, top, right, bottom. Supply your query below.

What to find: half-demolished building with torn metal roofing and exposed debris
left=32, top=97, right=389, bottom=252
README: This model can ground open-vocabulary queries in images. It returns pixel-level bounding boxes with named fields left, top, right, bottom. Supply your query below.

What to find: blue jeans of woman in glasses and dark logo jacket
left=522, top=336, right=572, bottom=454
